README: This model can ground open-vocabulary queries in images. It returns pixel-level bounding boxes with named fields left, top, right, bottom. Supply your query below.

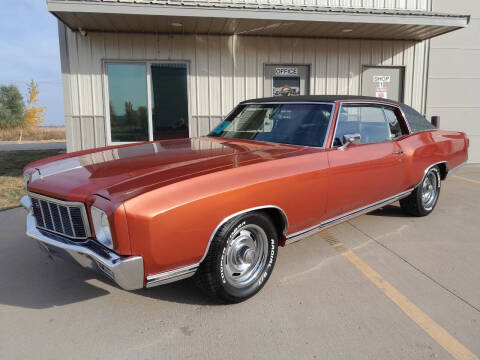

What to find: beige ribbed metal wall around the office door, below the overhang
left=59, top=24, right=426, bottom=151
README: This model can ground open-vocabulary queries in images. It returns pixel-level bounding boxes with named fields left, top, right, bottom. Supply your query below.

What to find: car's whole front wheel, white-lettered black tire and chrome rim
left=196, top=212, right=278, bottom=303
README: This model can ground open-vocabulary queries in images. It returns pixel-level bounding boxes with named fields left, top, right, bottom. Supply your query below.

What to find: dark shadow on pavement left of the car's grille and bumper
left=0, top=208, right=110, bottom=309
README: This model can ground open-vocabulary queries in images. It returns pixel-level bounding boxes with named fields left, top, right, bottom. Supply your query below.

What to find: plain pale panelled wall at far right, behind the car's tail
left=427, top=0, right=480, bottom=163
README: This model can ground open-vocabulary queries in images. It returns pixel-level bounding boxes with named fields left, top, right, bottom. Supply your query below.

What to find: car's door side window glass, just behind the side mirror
left=333, top=105, right=391, bottom=146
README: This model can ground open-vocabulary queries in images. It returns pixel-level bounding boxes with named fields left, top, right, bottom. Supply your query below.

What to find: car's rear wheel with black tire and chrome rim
left=400, top=166, right=441, bottom=216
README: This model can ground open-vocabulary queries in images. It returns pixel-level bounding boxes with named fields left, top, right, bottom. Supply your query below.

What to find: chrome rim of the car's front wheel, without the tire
left=223, top=224, right=268, bottom=287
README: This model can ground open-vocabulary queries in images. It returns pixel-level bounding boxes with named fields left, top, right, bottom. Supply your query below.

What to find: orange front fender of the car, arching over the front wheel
left=125, top=150, right=328, bottom=276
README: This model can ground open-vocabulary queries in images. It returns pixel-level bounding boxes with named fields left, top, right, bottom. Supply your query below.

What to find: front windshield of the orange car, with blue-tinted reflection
left=208, top=104, right=333, bottom=147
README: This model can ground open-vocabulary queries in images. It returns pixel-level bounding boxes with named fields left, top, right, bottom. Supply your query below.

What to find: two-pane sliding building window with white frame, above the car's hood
left=106, top=62, right=189, bottom=143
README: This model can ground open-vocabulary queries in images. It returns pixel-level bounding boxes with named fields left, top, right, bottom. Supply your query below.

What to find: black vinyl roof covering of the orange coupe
left=240, top=95, right=436, bottom=133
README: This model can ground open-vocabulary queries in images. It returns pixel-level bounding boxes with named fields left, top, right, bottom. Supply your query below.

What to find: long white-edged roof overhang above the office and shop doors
left=47, top=0, right=470, bottom=41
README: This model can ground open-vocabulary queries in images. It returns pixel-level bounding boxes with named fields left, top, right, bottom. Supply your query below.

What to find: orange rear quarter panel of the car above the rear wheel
left=399, top=130, right=468, bottom=188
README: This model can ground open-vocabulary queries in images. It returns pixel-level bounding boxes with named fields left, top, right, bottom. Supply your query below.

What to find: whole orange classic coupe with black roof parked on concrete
left=22, top=96, right=469, bottom=302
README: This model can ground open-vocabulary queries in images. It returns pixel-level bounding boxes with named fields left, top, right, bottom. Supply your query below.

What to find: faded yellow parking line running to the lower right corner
left=322, top=233, right=479, bottom=360
